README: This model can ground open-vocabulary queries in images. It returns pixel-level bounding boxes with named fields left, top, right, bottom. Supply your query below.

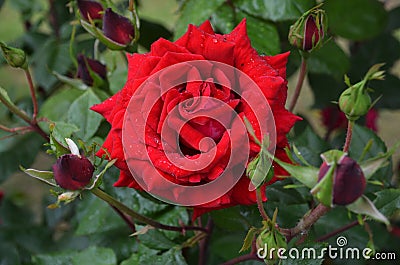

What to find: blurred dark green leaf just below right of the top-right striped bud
left=307, top=40, right=350, bottom=79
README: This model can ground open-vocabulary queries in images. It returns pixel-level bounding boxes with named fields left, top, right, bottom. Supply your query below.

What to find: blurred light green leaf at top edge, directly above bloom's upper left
left=174, top=0, right=225, bottom=39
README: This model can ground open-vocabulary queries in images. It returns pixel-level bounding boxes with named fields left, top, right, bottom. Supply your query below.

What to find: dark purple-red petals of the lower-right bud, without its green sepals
left=318, top=156, right=366, bottom=205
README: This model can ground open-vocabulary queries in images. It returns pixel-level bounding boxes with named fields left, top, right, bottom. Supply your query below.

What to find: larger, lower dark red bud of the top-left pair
left=103, top=8, right=135, bottom=45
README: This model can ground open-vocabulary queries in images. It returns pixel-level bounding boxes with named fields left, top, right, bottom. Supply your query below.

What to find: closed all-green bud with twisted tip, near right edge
left=339, top=64, right=384, bottom=121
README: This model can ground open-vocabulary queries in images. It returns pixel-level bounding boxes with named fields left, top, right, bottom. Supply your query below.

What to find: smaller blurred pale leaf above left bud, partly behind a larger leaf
left=38, top=89, right=84, bottom=121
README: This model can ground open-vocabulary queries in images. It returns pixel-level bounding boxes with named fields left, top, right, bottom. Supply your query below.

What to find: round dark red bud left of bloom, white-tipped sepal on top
left=53, top=154, right=94, bottom=190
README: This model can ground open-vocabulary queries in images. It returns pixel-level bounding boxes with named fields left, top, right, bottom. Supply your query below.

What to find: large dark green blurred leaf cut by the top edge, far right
left=324, top=0, right=387, bottom=40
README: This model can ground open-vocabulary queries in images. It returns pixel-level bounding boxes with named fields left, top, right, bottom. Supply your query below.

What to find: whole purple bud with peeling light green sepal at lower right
left=311, top=150, right=366, bottom=206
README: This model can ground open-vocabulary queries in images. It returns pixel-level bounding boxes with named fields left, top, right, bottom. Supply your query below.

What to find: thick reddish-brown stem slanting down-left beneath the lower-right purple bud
left=280, top=203, right=331, bottom=242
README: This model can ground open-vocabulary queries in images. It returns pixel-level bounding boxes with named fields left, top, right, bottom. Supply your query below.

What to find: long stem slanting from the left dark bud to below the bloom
left=91, top=188, right=208, bottom=233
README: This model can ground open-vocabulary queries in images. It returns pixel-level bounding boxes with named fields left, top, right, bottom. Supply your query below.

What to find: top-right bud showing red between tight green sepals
left=289, top=5, right=328, bottom=52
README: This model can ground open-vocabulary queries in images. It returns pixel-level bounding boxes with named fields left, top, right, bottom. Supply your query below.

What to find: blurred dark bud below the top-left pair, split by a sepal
left=77, top=54, right=107, bottom=86
